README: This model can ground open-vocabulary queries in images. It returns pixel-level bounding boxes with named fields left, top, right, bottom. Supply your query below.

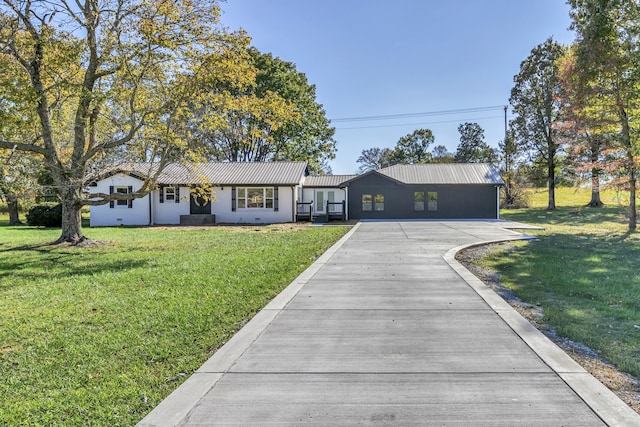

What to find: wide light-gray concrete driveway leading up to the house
left=139, top=221, right=640, bottom=426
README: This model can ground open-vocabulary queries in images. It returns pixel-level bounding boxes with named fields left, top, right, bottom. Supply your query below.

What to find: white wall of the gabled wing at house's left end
left=89, top=174, right=150, bottom=227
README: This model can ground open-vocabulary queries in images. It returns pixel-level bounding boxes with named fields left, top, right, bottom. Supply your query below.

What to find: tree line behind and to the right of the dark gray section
left=358, top=0, right=640, bottom=229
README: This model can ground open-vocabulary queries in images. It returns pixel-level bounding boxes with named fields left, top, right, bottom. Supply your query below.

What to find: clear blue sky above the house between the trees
left=222, top=0, right=574, bottom=175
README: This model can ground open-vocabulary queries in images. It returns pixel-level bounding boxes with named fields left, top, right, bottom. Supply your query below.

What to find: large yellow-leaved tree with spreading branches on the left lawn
left=0, top=0, right=254, bottom=243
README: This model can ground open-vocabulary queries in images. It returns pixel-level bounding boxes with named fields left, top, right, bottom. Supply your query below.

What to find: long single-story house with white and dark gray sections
left=90, top=162, right=504, bottom=227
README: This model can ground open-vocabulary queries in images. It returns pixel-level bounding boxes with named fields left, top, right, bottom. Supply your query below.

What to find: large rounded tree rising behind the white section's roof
left=193, top=48, right=336, bottom=172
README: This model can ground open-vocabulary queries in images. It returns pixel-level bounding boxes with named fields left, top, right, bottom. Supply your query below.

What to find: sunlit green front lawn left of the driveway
left=0, top=222, right=347, bottom=426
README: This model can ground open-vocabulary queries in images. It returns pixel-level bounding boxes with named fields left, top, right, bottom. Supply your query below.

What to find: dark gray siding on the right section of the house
left=349, top=174, right=498, bottom=219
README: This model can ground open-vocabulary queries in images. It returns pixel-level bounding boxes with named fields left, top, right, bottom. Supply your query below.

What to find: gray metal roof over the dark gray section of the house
left=376, top=163, right=504, bottom=185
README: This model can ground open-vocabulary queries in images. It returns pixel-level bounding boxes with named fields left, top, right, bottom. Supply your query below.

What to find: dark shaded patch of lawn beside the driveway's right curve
left=489, top=229, right=640, bottom=377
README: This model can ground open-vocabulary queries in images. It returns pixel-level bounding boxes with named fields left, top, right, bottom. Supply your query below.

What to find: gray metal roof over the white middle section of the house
left=158, top=162, right=309, bottom=185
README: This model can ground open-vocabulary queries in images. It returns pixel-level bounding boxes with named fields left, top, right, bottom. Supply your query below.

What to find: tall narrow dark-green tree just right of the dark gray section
left=509, top=38, right=565, bottom=209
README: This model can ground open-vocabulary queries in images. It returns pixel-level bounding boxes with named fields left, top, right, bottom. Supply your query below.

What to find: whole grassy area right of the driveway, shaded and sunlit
left=482, top=188, right=640, bottom=377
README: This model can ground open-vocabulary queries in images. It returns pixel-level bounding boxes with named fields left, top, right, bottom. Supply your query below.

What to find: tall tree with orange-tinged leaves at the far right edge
left=569, top=0, right=640, bottom=230
